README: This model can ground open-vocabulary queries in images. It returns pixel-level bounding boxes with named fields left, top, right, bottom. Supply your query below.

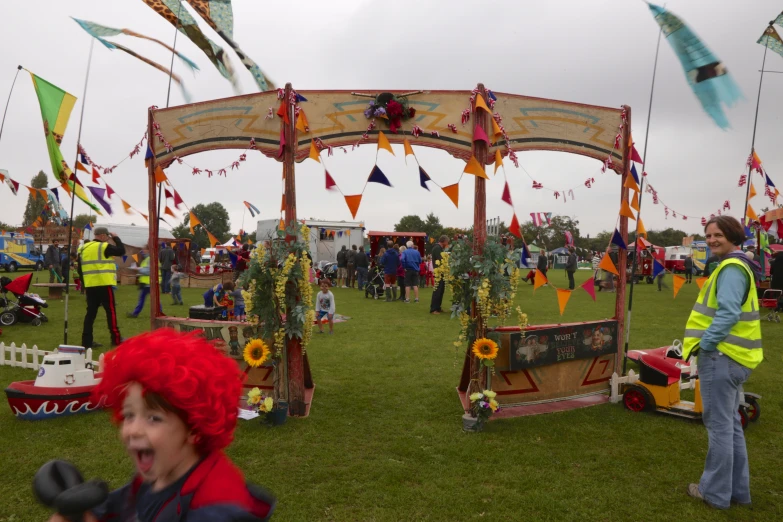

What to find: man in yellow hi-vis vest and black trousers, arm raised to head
left=78, top=227, right=125, bottom=348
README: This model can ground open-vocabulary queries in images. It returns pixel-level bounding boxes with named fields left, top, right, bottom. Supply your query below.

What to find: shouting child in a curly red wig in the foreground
left=51, top=329, right=275, bottom=522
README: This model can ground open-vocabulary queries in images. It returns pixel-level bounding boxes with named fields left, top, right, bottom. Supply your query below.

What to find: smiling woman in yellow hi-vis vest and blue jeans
left=682, top=216, right=763, bottom=509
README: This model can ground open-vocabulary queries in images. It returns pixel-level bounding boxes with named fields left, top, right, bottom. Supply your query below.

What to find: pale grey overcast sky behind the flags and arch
left=0, top=0, right=783, bottom=235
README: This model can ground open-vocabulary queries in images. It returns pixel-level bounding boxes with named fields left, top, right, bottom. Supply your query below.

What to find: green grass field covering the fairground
left=0, top=271, right=783, bottom=522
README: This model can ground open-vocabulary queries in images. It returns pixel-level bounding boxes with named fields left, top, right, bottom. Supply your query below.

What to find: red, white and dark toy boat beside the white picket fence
left=5, top=345, right=101, bottom=420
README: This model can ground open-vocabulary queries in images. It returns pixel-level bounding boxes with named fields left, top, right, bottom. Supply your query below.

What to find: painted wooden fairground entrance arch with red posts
left=148, top=84, right=631, bottom=415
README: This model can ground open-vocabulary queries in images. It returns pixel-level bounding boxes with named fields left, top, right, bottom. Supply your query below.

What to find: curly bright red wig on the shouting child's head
left=93, top=328, right=242, bottom=455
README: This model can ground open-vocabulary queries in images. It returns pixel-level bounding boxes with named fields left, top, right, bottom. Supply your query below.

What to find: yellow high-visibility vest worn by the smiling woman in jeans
left=682, top=259, right=764, bottom=370
